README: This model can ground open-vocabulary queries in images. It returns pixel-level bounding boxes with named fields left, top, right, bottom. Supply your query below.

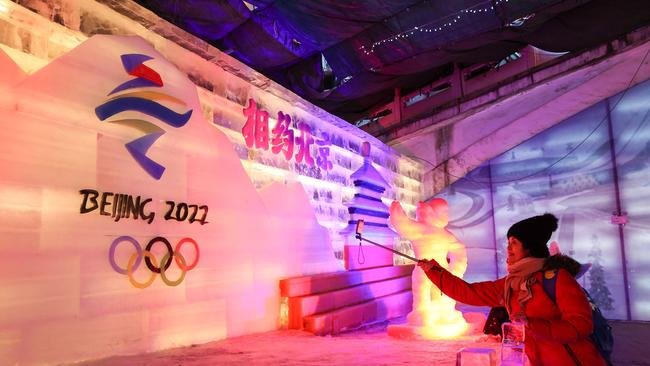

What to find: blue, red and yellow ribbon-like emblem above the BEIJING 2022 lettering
left=95, top=54, right=192, bottom=180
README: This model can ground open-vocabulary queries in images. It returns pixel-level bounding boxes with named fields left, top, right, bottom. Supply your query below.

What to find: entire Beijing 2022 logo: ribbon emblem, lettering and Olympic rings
left=91, top=54, right=197, bottom=289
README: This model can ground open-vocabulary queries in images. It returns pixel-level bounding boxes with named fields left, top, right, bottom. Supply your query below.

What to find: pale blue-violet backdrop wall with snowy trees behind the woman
left=432, top=76, right=650, bottom=321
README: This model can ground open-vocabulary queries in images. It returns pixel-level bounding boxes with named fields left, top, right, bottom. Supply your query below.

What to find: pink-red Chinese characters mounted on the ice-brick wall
left=242, top=99, right=332, bottom=170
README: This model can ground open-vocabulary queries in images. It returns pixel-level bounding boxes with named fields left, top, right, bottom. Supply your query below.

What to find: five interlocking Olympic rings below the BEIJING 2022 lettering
left=108, top=235, right=199, bottom=289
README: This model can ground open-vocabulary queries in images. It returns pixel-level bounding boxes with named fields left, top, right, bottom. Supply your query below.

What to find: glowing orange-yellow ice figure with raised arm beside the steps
left=390, top=198, right=468, bottom=339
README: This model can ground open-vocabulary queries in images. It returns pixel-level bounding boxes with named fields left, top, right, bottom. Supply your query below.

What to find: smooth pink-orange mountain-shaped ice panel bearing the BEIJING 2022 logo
left=0, top=36, right=339, bottom=364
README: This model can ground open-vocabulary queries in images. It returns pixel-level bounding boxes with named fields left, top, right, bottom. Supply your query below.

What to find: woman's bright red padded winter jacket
left=426, top=268, right=605, bottom=366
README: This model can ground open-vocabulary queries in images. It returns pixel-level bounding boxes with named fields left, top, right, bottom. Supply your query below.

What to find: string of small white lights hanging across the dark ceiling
left=359, top=0, right=509, bottom=55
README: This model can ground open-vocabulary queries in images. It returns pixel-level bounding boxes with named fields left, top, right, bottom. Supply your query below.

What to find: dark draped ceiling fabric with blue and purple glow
left=137, top=0, right=650, bottom=122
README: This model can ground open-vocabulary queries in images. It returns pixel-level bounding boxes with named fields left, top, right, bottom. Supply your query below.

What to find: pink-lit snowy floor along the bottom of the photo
left=71, top=322, right=650, bottom=366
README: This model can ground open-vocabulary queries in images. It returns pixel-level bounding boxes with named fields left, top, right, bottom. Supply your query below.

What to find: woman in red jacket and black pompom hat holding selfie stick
left=418, top=213, right=606, bottom=366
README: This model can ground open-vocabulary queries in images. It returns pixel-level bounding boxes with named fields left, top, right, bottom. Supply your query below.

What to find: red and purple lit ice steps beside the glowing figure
left=280, top=265, right=414, bottom=335
